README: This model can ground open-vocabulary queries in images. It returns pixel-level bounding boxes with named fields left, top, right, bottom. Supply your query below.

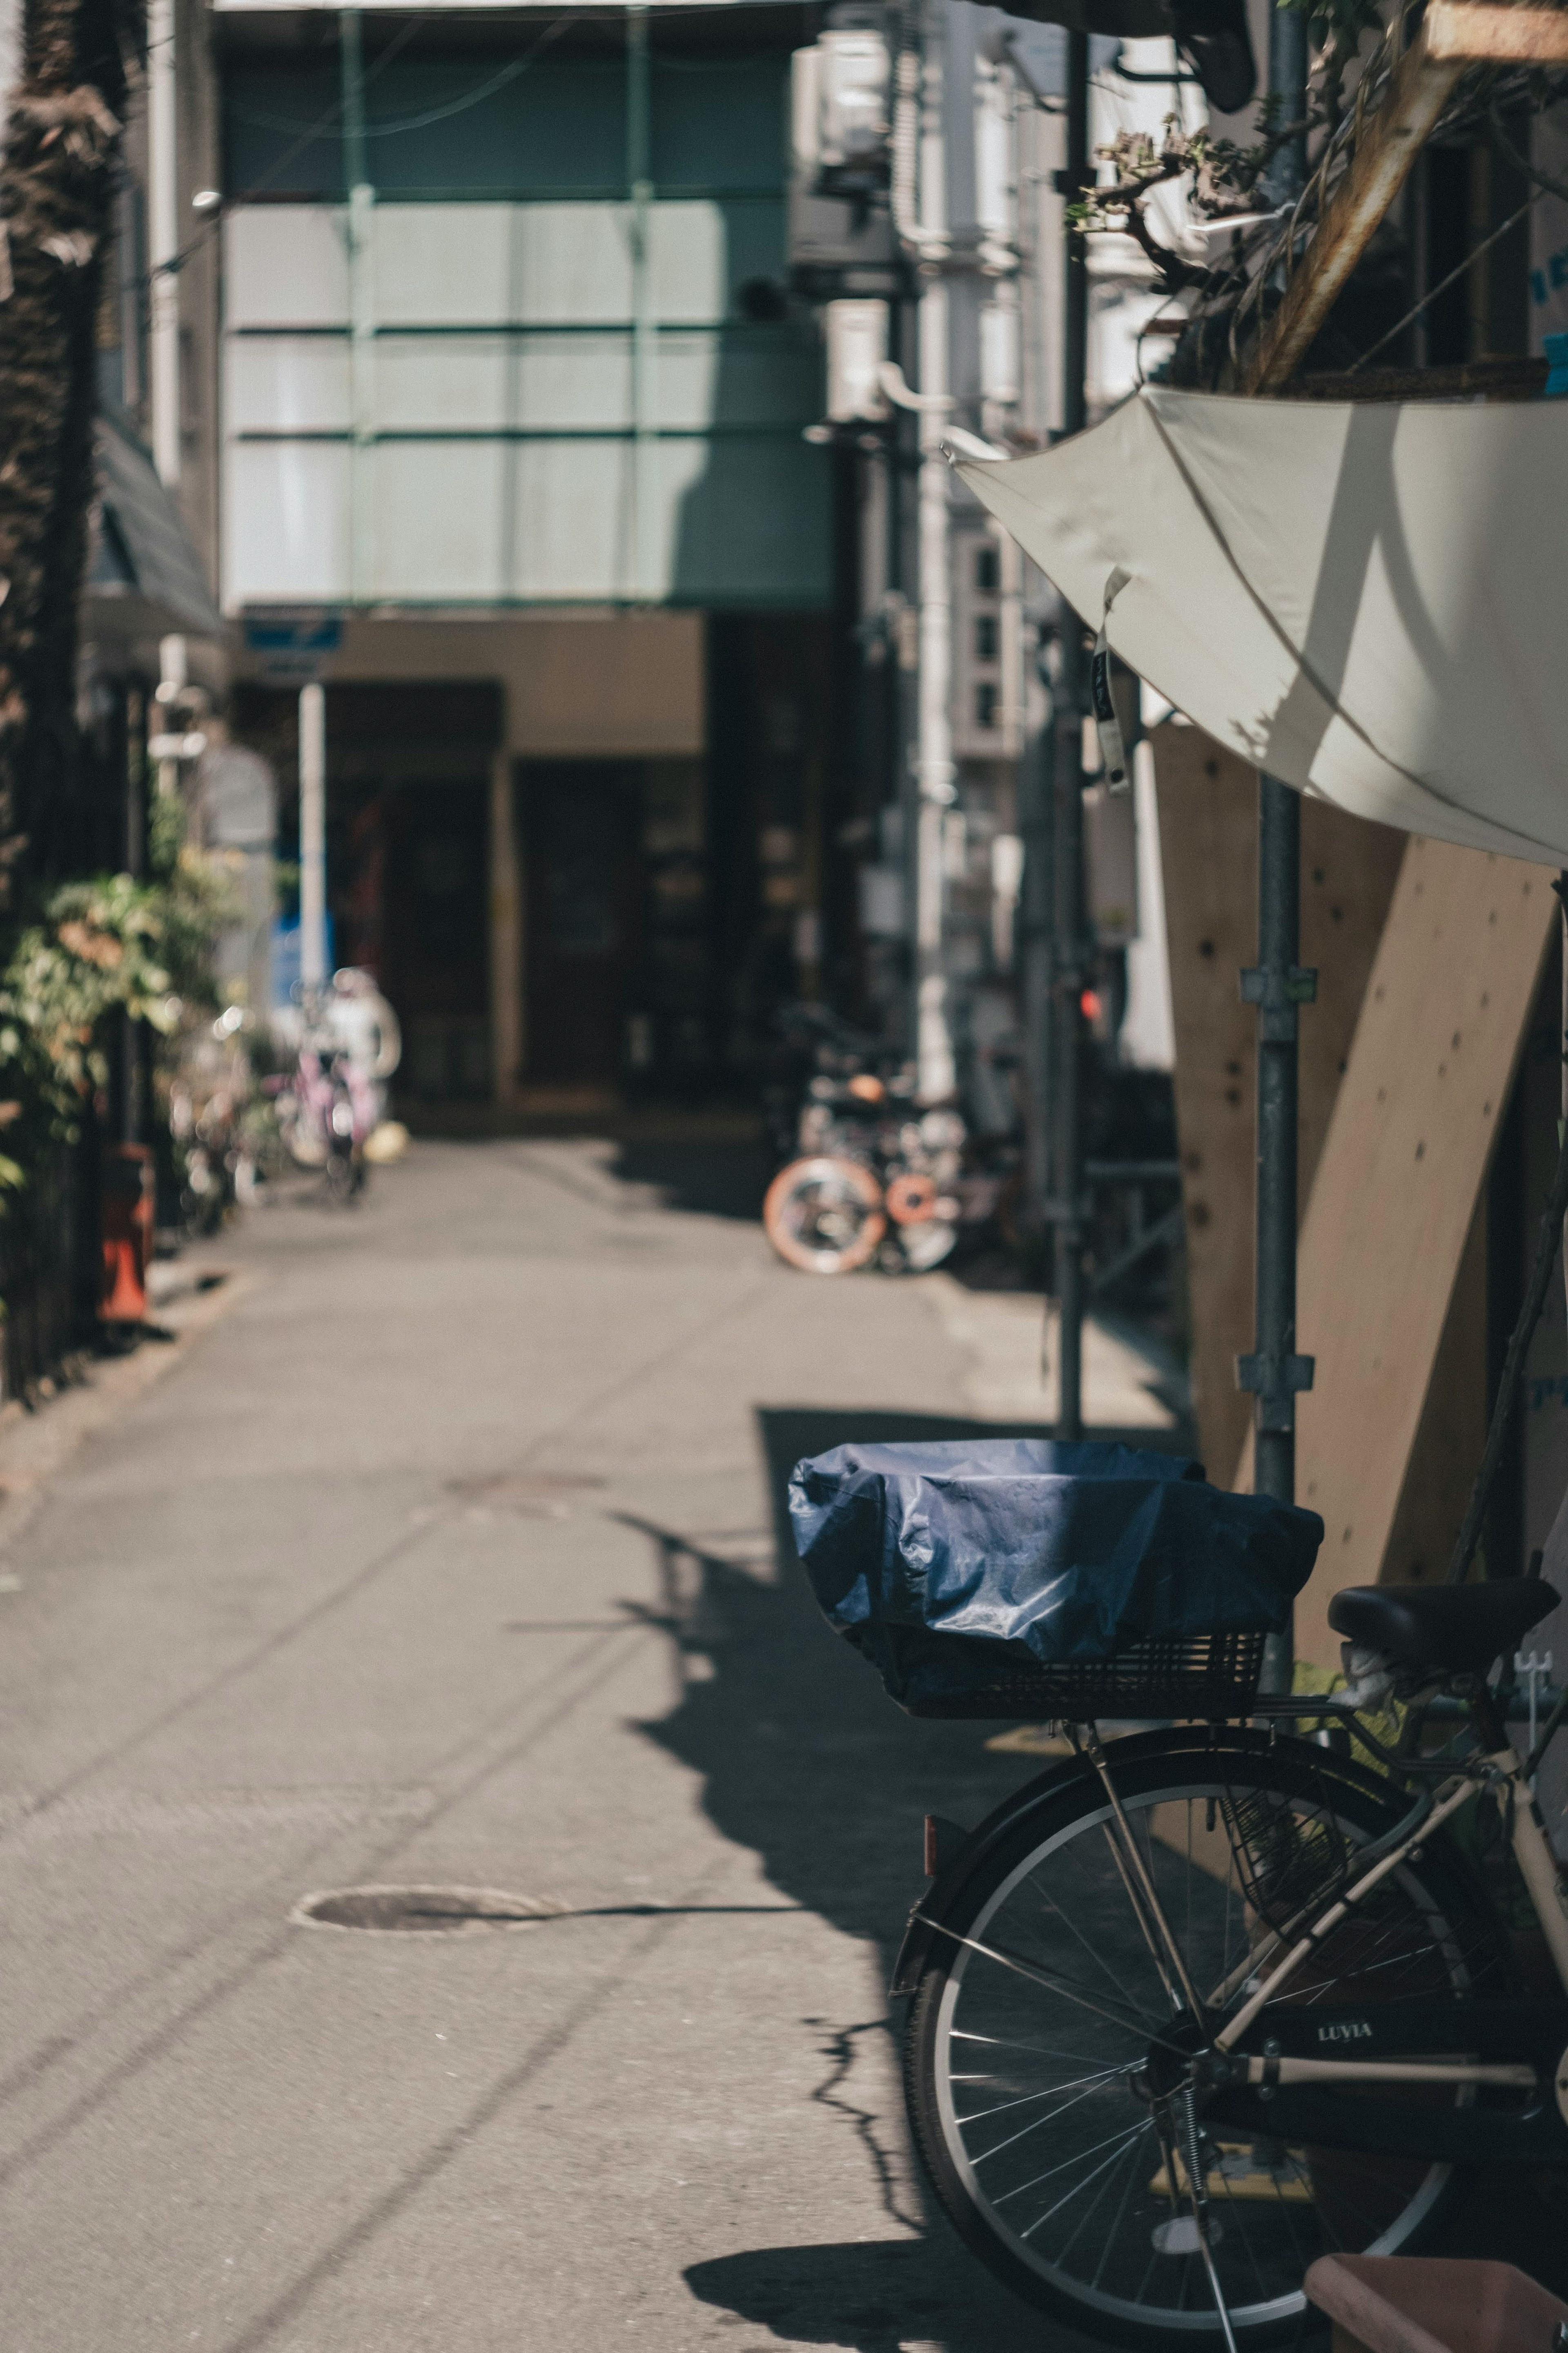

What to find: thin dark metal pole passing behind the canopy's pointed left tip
left=1051, top=33, right=1093, bottom=1440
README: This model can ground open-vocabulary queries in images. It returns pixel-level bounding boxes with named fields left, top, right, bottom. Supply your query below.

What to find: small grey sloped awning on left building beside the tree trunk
left=85, top=409, right=226, bottom=638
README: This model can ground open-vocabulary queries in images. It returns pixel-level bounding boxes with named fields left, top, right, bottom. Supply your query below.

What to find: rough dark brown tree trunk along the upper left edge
left=0, top=0, right=127, bottom=903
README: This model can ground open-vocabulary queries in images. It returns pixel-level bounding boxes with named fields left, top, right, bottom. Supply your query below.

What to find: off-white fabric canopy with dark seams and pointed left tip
left=959, top=388, right=1568, bottom=866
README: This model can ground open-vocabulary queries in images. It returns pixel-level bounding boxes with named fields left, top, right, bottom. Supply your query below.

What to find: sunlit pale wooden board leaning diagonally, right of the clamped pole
left=1236, top=838, right=1556, bottom=1666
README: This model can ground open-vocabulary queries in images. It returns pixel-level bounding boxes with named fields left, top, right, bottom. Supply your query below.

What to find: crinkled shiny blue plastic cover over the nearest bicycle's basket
left=790, top=1438, right=1323, bottom=1701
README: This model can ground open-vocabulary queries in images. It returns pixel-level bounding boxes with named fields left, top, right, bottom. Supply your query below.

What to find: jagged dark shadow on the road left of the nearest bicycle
left=635, top=1407, right=1185, bottom=2353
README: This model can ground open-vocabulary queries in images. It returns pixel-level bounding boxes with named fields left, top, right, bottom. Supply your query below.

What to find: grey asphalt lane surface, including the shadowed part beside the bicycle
left=0, top=1141, right=1171, bottom=2353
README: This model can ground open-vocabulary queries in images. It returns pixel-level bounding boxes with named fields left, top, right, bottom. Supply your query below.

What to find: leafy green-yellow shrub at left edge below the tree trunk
left=0, top=795, right=237, bottom=1195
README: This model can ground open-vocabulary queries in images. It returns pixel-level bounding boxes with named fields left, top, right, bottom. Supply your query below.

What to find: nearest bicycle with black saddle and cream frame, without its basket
left=893, top=1579, right=1568, bottom=2353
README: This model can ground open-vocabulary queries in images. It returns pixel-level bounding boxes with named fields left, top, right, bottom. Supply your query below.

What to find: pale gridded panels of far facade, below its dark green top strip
left=223, top=200, right=830, bottom=607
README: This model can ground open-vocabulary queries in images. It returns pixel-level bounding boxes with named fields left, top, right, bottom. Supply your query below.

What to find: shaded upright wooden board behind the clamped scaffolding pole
left=1152, top=725, right=1406, bottom=1480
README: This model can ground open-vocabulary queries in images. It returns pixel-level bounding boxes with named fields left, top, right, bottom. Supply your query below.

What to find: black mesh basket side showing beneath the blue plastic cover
left=900, top=1633, right=1265, bottom=1722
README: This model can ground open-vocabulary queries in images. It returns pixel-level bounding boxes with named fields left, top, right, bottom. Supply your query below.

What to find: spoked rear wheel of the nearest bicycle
left=905, top=1734, right=1509, bottom=2348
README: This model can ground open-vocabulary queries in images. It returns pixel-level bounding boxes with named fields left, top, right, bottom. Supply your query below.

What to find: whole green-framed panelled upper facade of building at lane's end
left=223, top=33, right=830, bottom=609
